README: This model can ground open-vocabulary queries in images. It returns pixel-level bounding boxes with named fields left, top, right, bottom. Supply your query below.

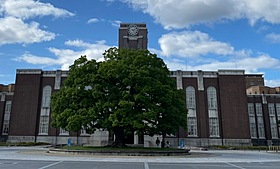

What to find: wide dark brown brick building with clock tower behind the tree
left=0, top=23, right=280, bottom=147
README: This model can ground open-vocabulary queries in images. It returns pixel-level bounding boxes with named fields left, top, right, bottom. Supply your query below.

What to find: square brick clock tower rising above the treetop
left=119, top=23, right=148, bottom=50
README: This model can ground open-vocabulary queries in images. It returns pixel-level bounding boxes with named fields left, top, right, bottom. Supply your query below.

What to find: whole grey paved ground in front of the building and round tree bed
left=0, top=147, right=280, bottom=169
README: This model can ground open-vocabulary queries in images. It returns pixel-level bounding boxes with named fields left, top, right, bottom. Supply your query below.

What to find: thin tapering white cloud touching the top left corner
left=0, top=0, right=75, bottom=19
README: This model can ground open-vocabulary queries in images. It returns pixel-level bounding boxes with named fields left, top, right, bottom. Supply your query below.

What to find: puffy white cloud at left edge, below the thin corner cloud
left=0, top=17, right=55, bottom=46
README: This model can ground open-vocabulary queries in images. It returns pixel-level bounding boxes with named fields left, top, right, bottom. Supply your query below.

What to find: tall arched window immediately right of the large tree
left=186, top=86, right=197, bottom=137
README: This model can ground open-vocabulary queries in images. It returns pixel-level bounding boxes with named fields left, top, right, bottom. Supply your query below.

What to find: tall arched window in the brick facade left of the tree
left=39, top=86, right=52, bottom=135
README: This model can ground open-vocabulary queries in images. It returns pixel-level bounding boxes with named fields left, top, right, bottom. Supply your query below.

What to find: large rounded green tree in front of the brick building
left=51, top=48, right=187, bottom=147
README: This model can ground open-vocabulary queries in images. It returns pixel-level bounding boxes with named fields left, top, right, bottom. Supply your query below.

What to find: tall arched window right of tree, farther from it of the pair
left=207, top=86, right=219, bottom=137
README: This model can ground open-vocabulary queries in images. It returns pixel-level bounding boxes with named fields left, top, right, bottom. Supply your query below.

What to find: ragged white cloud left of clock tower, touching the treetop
left=14, top=40, right=111, bottom=70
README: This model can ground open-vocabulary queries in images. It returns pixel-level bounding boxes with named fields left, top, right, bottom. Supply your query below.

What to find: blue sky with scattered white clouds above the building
left=0, top=0, right=280, bottom=87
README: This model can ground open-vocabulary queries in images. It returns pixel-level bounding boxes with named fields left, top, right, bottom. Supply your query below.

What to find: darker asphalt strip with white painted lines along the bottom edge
left=0, top=160, right=280, bottom=169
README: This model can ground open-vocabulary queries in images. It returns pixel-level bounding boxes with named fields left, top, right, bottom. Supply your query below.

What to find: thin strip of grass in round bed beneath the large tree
left=60, top=146, right=180, bottom=151
